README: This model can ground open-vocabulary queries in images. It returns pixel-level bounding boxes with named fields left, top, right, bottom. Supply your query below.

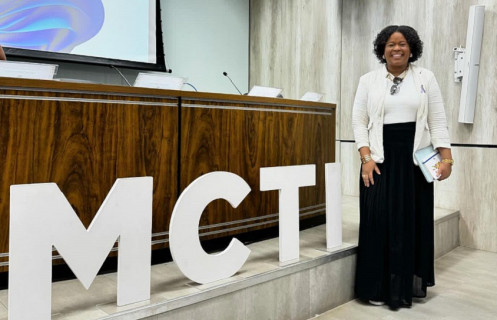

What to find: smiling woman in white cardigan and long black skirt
left=352, top=26, right=454, bottom=309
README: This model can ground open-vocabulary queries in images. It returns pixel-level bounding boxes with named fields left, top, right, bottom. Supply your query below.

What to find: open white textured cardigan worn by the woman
left=352, top=64, right=450, bottom=164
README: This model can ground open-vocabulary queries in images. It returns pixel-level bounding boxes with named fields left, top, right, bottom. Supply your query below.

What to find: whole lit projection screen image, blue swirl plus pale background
left=0, top=0, right=157, bottom=63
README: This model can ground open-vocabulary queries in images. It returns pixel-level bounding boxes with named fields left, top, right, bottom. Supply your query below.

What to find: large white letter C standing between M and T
left=169, top=172, right=250, bottom=283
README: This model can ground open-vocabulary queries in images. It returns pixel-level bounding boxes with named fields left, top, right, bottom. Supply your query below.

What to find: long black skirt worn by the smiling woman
left=355, top=122, right=435, bottom=309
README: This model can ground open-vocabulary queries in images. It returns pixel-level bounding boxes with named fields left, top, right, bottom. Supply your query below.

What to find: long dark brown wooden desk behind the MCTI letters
left=0, top=78, right=335, bottom=271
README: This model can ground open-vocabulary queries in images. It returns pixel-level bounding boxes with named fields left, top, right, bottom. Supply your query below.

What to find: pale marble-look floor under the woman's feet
left=312, top=247, right=497, bottom=320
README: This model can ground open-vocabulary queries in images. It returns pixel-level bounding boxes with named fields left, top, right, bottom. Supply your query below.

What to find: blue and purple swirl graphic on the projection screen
left=0, top=0, right=105, bottom=53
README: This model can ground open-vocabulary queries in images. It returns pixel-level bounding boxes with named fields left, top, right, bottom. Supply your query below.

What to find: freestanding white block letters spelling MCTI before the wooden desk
left=8, top=163, right=342, bottom=320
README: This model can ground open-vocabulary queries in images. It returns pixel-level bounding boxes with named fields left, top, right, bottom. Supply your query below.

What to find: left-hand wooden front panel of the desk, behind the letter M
left=0, top=89, right=178, bottom=270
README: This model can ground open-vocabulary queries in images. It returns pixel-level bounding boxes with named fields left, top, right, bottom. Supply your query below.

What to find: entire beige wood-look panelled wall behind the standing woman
left=250, top=0, right=497, bottom=252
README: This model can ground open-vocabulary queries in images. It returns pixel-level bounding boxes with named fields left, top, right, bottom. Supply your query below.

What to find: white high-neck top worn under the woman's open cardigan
left=383, top=71, right=421, bottom=124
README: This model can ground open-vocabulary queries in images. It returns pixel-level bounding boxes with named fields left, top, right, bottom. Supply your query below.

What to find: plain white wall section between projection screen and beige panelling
left=161, top=0, right=250, bottom=94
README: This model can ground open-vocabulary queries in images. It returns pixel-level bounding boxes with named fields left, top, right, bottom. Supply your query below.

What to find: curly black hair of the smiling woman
left=373, top=25, right=423, bottom=63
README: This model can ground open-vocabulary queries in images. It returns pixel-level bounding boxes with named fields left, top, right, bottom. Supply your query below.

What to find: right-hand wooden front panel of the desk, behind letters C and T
left=180, top=99, right=335, bottom=240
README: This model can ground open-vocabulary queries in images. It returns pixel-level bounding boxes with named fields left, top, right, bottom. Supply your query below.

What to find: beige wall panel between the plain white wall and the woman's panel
left=250, top=0, right=341, bottom=103
